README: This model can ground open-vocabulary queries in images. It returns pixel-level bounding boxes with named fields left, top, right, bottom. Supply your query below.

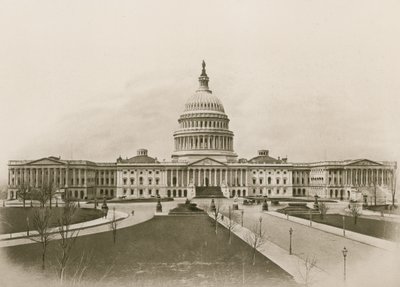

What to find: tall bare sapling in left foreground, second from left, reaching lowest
left=58, top=201, right=79, bottom=283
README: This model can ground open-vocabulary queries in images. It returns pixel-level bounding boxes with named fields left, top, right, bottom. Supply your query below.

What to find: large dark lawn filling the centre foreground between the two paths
left=4, top=216, right=297, bottom=286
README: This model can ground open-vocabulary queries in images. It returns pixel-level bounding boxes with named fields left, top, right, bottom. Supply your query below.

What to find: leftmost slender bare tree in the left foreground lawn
left=30, top=208, right=52, bottom=270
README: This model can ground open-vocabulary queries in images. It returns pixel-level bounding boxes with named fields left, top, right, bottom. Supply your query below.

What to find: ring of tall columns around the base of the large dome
left=175, top=135, right=233, bottom=151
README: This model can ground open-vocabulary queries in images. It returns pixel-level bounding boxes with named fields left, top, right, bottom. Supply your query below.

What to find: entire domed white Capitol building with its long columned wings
left=8, top=62, right=397, bottom=204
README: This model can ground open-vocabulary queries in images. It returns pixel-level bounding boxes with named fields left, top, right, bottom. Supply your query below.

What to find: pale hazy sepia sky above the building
left=0, top=0, right=400, bottom=186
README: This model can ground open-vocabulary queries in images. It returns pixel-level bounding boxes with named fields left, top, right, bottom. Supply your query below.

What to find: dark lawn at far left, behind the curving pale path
left=0, top=207, right=102, bottom=234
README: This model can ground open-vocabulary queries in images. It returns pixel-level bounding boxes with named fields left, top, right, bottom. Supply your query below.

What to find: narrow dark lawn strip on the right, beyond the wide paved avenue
left=292, top=214, right=400, bottom=241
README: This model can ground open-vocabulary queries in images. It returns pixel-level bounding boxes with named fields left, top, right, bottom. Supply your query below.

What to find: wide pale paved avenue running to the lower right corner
left=244, top=206, right=400, bottom=286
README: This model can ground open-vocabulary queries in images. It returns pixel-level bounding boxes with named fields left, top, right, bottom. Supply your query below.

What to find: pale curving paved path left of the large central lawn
left=0, top=200, right=181, bottom=250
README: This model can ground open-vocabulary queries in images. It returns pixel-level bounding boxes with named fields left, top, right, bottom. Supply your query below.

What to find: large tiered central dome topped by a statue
left=172, top=61, right=237, bottom=162
